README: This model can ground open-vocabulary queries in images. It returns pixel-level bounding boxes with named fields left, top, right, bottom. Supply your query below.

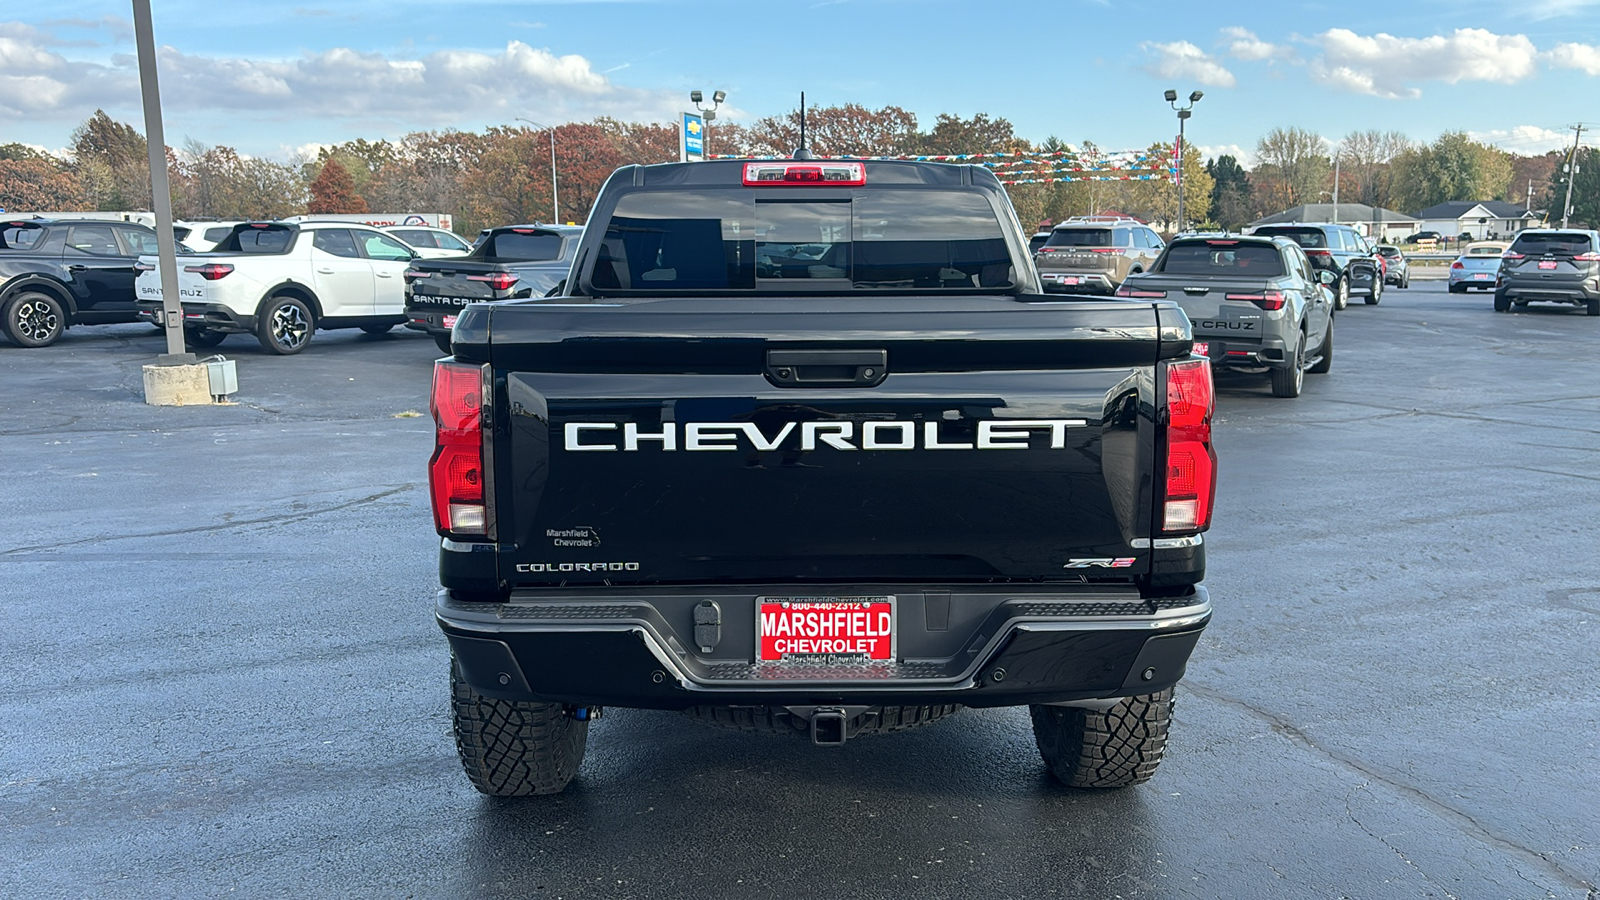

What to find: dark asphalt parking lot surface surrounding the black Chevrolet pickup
left=0, top=282, right=1600, bottom=900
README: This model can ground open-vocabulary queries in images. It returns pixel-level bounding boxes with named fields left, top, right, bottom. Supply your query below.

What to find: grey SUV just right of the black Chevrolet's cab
left=1034, top=216, right=1165, bottom=293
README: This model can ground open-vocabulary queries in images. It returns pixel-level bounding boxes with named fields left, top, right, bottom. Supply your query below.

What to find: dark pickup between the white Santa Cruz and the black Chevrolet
left=405, top=224, right=584, bottom=352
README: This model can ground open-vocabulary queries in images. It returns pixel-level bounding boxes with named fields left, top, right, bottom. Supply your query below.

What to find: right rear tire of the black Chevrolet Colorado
left=1027, top=687, right=1173, bottom=788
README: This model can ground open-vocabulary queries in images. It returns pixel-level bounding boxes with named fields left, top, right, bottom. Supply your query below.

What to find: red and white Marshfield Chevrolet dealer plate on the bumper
left=755, top=597, right=894, bottom=663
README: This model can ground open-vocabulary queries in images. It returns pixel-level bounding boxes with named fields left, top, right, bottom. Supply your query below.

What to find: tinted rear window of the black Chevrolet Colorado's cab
left=590, top=189, right=1014, bottom=293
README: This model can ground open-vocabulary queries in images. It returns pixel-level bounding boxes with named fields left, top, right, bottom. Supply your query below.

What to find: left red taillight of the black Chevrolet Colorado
left=427, top=360, right=488, bottom=535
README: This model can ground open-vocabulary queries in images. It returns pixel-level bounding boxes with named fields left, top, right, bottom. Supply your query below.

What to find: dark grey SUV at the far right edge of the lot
left=1494, top=229, right=1600, bottom=315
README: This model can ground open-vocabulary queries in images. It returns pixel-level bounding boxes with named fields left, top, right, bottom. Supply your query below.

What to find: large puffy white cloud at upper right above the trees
left=1310, top=29, right=1539, bottom=99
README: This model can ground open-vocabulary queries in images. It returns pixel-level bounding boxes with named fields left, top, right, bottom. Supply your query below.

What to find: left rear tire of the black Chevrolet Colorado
left=450, top=660, right=589, bottom=798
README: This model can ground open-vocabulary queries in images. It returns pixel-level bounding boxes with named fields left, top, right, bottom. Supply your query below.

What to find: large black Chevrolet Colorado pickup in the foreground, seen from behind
left=429, top=160, right=1216, bottom=796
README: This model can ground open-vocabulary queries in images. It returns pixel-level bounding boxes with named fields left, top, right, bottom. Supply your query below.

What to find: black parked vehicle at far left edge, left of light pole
left=0, top=218, right=164, bottom=348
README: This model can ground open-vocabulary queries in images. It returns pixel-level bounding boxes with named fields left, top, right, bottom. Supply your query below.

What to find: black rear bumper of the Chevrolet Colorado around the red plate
left=435, top=586, right=1211, bottom=709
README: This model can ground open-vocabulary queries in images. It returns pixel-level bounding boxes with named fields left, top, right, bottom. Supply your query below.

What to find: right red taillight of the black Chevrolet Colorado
left=1162, top=357, right=1216, bottom=533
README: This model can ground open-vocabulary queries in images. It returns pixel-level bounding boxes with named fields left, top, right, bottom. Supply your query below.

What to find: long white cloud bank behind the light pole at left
left=0, top=31, right=680, bottom=138
